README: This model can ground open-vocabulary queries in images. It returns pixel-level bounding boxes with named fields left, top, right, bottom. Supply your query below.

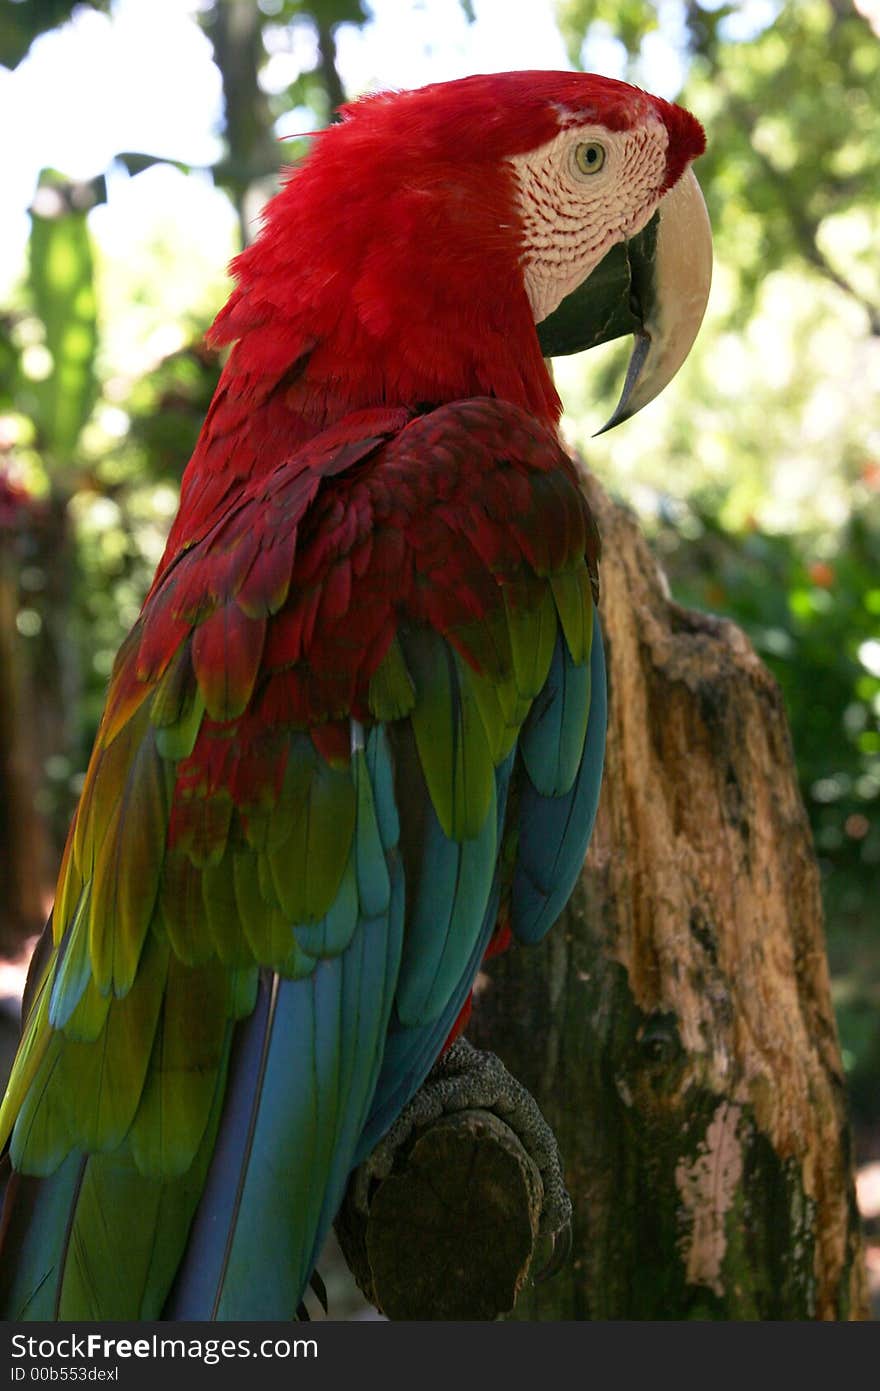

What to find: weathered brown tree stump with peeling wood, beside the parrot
left=339, top=480, right=867, bottom=1320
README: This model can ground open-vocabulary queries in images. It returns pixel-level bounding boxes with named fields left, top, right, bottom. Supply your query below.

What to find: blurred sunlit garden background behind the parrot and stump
left=0, top=0, right=880, bottom=1313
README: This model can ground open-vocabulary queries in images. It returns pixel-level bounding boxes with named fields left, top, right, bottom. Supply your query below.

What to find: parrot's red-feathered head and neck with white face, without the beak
left=161, top=72, right=705, bottom=559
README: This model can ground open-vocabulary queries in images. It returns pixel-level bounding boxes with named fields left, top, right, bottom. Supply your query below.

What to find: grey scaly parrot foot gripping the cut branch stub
left=350, top=1038, right=571, bottom=1280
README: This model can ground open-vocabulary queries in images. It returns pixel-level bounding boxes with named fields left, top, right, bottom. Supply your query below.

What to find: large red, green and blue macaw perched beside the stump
left=0, top=71, right=710, bottom=1321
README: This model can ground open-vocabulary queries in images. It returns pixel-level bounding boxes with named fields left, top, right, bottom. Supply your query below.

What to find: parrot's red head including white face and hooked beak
left=214, top=72, right=712, bottom=424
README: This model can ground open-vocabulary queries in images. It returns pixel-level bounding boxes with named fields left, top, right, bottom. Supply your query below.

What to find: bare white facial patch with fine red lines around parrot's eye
left=510, top=113, right=669, bottom=324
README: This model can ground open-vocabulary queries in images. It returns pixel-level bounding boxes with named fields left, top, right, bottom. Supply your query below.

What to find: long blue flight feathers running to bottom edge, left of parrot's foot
left=165, top=730, right=405, bottom=1319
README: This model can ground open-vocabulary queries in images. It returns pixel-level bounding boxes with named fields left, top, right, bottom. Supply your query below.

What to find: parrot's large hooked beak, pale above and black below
left=538, top=168, right=712, bottom=434
